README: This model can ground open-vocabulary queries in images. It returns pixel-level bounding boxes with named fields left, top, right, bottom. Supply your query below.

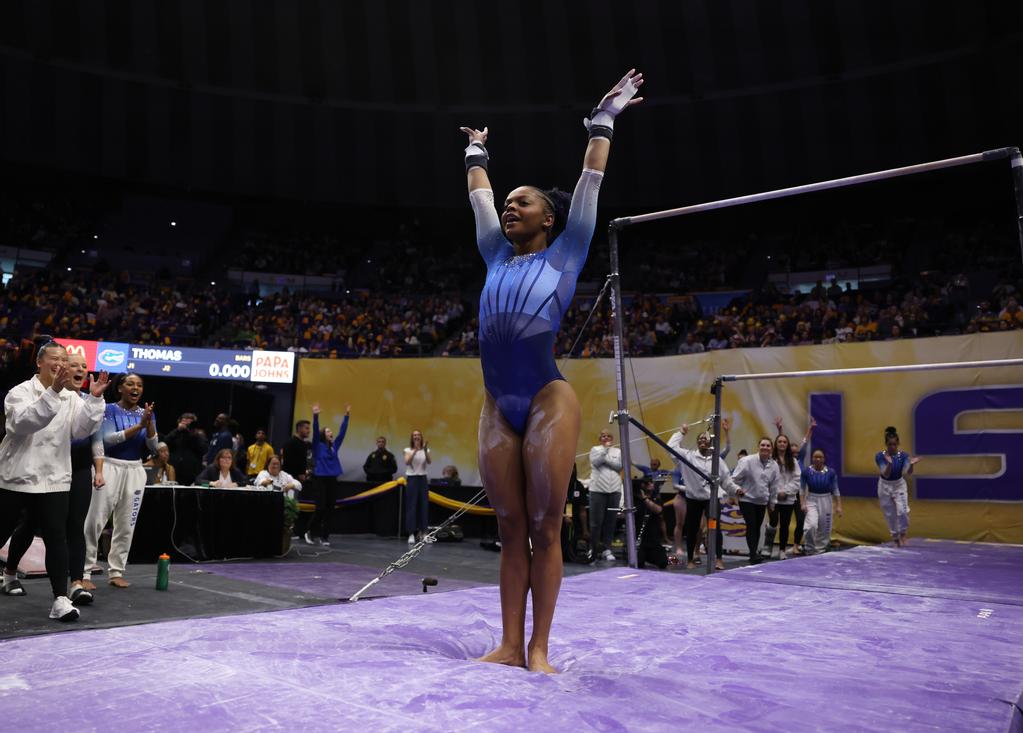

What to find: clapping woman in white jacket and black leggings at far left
left=0, top=341, right=108, bottom=622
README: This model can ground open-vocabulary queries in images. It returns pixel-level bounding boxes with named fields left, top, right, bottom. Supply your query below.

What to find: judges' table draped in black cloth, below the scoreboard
left=129, top=486, right=284, bottom=562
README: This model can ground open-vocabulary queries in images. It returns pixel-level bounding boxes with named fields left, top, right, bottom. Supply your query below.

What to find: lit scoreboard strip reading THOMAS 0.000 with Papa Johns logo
left=56, top=338, right=295, bottom=384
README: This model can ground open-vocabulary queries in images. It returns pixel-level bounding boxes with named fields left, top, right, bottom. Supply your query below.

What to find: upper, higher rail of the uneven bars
left=611, top=147, right=1019, bottom=229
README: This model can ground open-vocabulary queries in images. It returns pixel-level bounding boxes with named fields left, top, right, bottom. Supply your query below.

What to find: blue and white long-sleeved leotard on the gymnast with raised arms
left=469, top=169, right=604, bottom=434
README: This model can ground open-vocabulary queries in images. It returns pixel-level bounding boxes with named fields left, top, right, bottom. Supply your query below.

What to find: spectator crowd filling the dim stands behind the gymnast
left=0, top=174, right=1023, bottom=358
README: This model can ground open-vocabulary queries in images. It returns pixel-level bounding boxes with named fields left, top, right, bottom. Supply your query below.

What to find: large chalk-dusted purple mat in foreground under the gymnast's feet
left=0, top=539, right=1023, bottom=733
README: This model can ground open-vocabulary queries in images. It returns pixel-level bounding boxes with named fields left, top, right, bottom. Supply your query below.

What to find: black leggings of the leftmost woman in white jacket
left=0, top=489, right=70, bottom=598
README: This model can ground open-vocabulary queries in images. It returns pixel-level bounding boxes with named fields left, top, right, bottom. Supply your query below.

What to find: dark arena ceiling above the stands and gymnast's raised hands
left=0, top=0, right=1023, bottom=210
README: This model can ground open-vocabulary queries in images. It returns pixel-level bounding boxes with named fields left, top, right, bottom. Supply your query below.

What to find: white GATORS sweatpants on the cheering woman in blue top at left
left=84, top=457, right=145, bottom=580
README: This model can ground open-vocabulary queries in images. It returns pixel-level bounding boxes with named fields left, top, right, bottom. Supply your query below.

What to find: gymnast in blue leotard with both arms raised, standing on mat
left=461, top=70, right=642, bottom=673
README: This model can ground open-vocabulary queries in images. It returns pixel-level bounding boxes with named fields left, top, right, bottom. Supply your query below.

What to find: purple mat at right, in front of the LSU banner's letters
left=728, top=540, right=1023, bottom=605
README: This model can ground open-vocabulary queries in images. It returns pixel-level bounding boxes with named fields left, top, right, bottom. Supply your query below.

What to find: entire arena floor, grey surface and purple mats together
left=0, top=538, right=1023, bottom=732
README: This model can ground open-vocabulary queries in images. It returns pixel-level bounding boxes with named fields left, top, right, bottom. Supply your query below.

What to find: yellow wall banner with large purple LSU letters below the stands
left=295, top=331, right=1023, bottom=543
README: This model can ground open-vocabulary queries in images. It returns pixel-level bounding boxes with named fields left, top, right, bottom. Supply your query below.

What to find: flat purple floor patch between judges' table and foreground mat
left=203, top=562, right=480, bottom=598
